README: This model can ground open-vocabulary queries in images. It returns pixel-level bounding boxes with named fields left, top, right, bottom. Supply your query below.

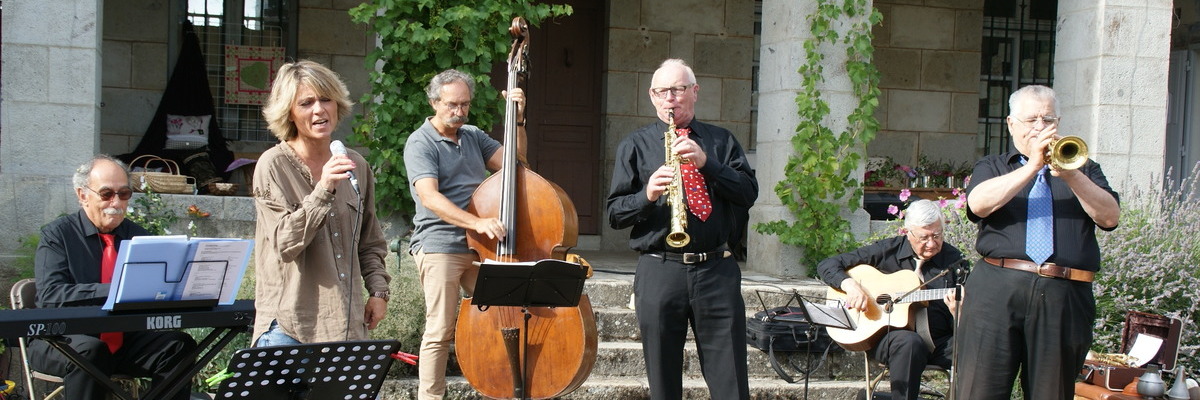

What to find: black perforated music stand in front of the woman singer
left=216, top=340, right=400, bottom=400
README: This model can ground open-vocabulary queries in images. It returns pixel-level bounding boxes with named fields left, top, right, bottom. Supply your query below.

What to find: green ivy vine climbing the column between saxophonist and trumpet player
left=755, top=0, right=883, bottom=265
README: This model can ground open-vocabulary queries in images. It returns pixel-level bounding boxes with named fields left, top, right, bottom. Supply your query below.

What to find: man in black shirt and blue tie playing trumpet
left=954, top=85, right=1121, bottom=400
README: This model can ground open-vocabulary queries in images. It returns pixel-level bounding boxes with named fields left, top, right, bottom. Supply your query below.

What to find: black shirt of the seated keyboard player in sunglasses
left=34, top=210, right=150, bottom=309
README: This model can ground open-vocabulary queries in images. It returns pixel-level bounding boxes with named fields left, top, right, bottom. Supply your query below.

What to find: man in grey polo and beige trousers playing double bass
left=404, top=70, right=526, bottom=399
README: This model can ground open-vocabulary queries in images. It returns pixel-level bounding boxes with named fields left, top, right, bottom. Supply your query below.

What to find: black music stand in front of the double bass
left=470, top=259, right=587, bottom=400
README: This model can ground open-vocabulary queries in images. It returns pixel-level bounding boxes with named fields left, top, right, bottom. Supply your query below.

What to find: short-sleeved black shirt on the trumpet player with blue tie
left=967, top=151, right=1121, bottom=271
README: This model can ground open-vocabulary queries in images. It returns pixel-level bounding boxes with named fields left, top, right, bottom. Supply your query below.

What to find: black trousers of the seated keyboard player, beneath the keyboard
left=29, top=330, right=196, bottom=400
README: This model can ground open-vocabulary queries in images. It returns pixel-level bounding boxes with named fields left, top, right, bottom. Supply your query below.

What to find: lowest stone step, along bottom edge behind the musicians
left=379, top=376, right=864, bottom=400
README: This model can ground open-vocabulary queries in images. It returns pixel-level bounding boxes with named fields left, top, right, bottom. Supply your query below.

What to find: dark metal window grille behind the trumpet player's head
left=979, top=0, right=1058, bottom=155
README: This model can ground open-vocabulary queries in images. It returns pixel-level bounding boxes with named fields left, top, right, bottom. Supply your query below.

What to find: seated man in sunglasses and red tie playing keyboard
left=29, top=155, right=196, bottom=400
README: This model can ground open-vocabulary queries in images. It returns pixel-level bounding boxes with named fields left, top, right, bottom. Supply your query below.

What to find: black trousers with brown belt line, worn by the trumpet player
left=954, top=259, right=1096, bottom=400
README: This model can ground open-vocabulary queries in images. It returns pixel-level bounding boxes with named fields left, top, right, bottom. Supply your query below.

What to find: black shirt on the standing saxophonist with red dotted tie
left=607, top=120, right=758, bottom=252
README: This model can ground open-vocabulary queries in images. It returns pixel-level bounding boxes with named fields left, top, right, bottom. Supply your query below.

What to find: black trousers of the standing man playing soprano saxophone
left=634, top=255, right=750, bottom=400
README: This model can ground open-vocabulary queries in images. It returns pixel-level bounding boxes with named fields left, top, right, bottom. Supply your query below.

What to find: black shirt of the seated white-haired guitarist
left=817, top=235, right=962, bottom=338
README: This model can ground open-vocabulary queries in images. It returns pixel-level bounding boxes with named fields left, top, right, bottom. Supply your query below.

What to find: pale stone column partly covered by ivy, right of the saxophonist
left=746, top=0, right=870, bottom=276
